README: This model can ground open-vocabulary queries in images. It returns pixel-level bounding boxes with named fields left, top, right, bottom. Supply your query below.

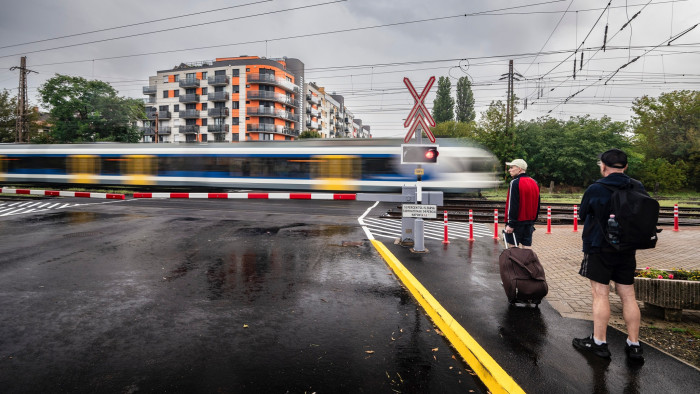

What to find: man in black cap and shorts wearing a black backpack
left=573, top=149, right=658, bottom=363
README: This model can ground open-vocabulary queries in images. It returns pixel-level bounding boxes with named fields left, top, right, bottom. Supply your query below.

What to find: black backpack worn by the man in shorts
left=597, top=182, right=661, bottom=250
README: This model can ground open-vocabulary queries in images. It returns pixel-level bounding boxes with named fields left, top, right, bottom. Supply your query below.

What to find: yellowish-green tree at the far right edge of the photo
left=632, top=90, right=700, bottom=190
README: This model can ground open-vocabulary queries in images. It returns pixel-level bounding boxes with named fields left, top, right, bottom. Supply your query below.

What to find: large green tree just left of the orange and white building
left=39, top=74, right=145, bottom=143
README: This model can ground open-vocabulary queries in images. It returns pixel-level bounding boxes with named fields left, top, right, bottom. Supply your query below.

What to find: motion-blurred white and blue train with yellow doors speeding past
left=0, top=139, right=498, bottom=193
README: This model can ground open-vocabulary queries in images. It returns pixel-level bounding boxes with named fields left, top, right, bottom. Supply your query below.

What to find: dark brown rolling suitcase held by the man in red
left=498, top=231, right=549, bottom=306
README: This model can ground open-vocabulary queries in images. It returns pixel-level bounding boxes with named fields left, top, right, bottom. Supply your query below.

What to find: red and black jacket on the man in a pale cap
left=505, top=174, right=540, bottom=227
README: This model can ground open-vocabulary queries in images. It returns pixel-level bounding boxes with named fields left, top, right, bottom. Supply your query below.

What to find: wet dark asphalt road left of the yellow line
left=0, top=199, right=484, bottom=393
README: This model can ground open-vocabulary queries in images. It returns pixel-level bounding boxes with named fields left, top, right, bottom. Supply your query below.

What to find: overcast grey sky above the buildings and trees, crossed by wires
left=0, top=0, right=700, bottom=137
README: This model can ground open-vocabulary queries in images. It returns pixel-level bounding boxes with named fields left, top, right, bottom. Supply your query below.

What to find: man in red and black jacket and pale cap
left=505, top=159, right=540, bottom=248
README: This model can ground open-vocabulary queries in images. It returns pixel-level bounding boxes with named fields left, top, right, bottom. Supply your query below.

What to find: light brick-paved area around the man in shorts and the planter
left=533, top=225, right=700, bottom=331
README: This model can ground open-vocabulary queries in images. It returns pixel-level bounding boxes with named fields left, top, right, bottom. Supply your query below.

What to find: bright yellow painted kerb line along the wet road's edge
left=371, top=239, right=525, bottom=393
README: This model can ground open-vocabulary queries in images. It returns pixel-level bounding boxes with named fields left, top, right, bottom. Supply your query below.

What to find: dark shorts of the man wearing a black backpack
left=578, top=250, right=637, bottom=285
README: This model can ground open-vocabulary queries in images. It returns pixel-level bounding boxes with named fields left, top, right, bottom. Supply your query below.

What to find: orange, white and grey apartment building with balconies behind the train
left=142, top=56, right=368, bottom=142
